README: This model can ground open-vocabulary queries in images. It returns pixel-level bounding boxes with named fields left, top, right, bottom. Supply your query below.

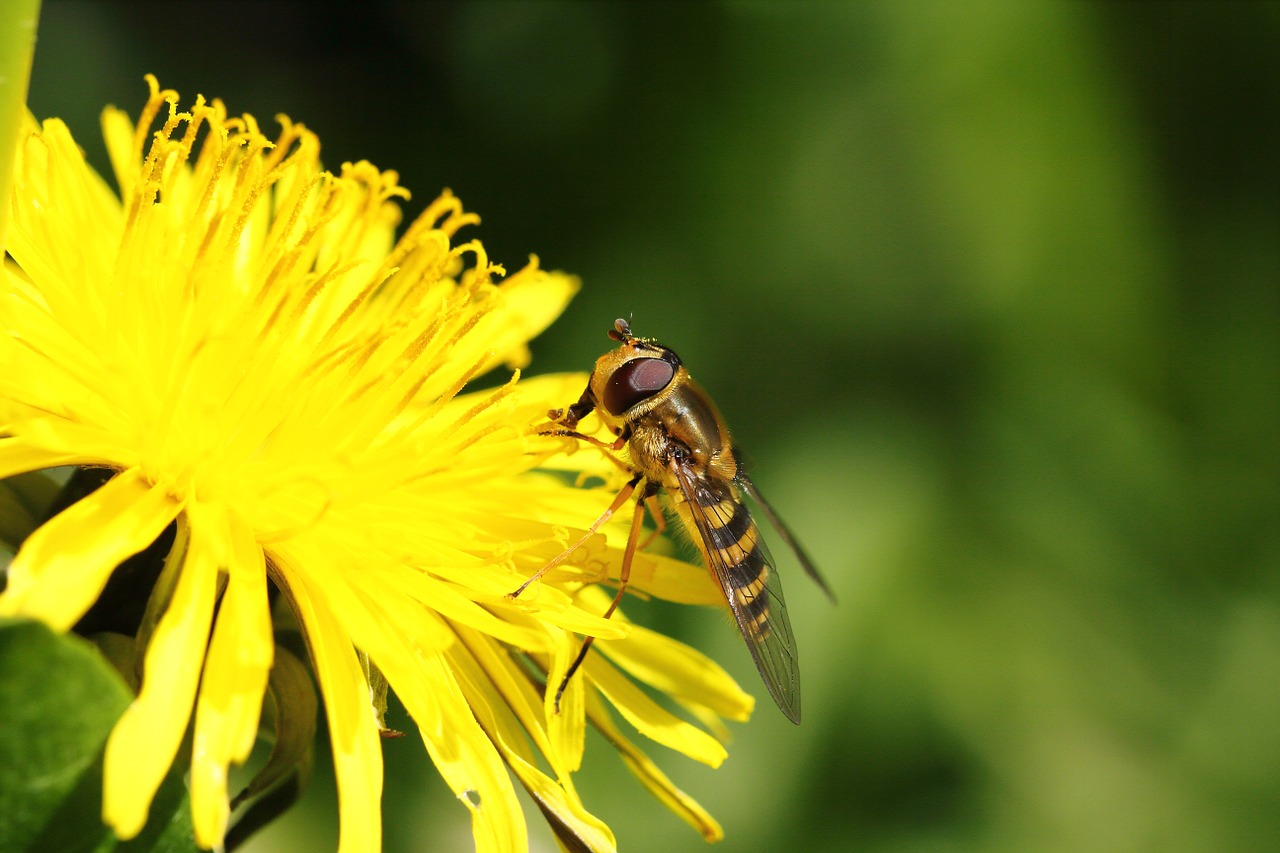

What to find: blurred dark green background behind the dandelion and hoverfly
left=31, top=0, right=1280, bottom=853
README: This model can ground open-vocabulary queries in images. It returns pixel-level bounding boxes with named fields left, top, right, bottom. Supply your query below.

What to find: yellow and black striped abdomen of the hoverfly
left=701, top=496, right=769, bottom=639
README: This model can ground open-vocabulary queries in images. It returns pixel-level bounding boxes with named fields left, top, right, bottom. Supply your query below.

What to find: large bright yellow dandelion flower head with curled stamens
left=0, top=78, right=751, bottom=850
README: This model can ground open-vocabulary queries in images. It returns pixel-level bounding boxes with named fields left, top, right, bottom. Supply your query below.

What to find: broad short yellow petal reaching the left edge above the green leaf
left=0, top=470, right=179, bottom=630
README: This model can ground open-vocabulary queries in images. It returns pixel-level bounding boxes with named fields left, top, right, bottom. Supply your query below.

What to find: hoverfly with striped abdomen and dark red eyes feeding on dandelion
left=512, top=320, right=835, bottom=724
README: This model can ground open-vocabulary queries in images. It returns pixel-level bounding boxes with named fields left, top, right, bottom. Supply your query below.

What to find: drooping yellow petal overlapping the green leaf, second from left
left=101, top=504, right=218, bottom=839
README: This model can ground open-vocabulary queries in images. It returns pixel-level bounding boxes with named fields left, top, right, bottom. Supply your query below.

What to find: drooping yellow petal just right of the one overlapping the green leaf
left=188, top=507, right=274, bottom=848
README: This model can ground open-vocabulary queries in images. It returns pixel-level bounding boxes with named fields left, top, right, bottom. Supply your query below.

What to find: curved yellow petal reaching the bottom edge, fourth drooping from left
left=276, top=561, right=383, bottom=853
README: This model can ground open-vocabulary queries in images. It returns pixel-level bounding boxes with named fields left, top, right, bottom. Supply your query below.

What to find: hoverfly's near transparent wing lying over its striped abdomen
left=671, top=461, right=800, bottom=724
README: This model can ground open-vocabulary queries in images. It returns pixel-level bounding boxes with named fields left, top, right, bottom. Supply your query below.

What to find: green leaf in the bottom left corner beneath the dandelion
left=0, top=619, right=196, bottom=853
